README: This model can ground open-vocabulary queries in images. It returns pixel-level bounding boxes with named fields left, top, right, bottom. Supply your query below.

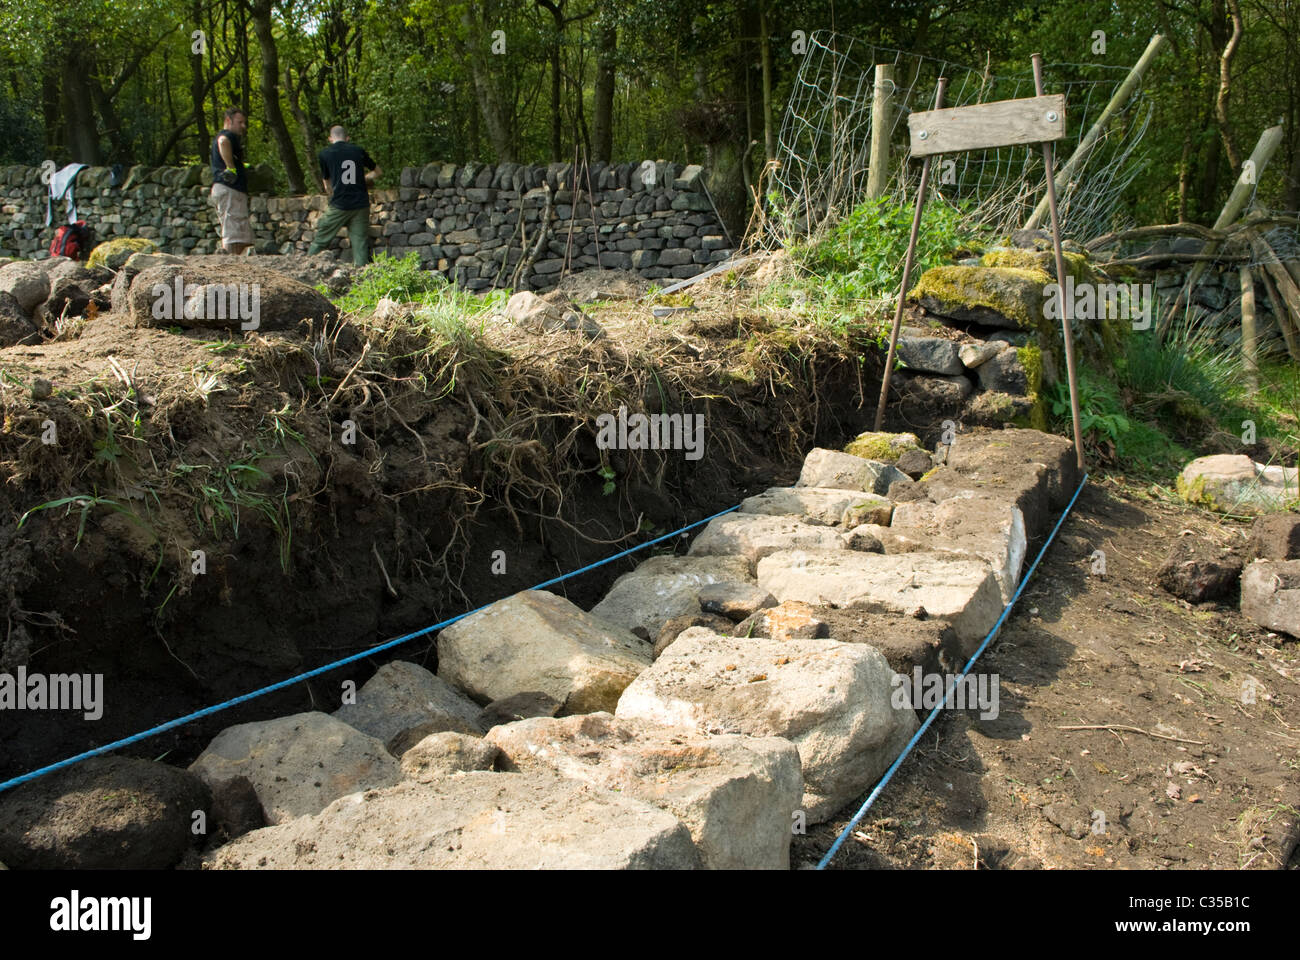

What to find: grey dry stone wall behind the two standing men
left=0, top=161, right=732, bottom=290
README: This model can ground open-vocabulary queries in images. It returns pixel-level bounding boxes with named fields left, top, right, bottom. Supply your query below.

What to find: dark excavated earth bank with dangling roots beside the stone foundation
left=0, top=293, right=915, bottom=779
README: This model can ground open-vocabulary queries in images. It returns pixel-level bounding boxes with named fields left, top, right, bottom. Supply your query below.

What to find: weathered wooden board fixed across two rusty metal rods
left=907, top=94, right=1065, bottom=156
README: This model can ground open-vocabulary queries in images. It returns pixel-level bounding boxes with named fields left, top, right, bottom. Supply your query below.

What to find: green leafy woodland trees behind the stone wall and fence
left=0, top=0, right=1300, bottom=222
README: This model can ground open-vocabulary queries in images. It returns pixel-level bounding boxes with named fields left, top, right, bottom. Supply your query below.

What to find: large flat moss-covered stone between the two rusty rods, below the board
left=907, top=267, right=1052, bottom=330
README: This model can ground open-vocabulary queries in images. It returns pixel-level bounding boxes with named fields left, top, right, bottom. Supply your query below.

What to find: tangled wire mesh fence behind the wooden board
left=761, top=31, right=1153, bottom=246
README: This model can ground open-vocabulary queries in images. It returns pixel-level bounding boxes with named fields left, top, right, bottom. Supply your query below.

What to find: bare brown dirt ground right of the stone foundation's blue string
left=792, top=480, right=1300, bottom=869
